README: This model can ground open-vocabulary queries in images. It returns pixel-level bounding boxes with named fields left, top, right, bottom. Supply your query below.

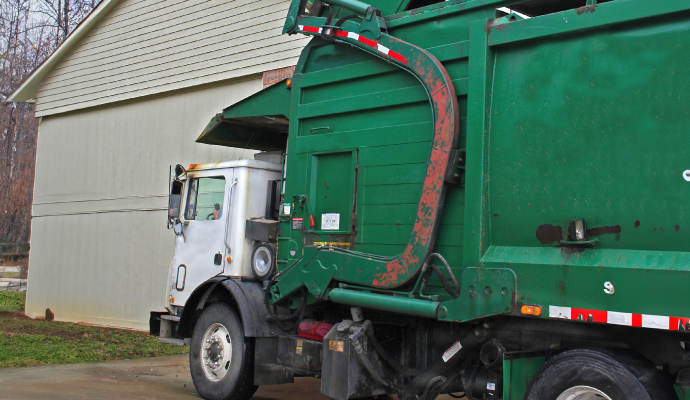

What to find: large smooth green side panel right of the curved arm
left=456, top=1, right=690, bottom=329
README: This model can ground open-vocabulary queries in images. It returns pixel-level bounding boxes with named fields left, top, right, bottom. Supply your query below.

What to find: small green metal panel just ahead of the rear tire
left=503, top=353, right=546, bottom=400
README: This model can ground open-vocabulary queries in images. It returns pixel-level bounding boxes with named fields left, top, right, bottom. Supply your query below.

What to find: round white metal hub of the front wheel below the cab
left=201, top=324, right=232, bottom=382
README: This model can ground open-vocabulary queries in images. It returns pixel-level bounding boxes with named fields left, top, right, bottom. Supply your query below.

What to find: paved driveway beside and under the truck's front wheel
left=0, top=354, right=462, bottom=400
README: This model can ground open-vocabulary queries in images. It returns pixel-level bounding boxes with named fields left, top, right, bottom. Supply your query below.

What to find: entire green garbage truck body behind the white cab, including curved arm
left=184, top=0, right=690, bottom=399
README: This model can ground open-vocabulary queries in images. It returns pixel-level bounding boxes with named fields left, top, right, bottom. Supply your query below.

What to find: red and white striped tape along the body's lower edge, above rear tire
left=549, top=306, right=690, bottom=331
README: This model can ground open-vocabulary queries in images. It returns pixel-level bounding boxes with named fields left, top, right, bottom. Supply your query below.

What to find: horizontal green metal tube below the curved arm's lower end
left=328, top=289, right=441, bottom=318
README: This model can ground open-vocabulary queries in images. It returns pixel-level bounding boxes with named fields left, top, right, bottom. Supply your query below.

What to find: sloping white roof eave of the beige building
left=6, top=0, right=120, bottom=102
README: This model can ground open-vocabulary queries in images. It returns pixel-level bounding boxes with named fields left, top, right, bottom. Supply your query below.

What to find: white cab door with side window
left=170, top=169, right=233, bottom=306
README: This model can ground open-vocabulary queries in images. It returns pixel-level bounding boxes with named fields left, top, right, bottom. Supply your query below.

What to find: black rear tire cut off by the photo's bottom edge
left=525, top=349, right=678, bottom=400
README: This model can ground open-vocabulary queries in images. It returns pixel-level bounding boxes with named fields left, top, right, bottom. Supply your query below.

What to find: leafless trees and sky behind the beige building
left=0, top=0, right=97, bottom=243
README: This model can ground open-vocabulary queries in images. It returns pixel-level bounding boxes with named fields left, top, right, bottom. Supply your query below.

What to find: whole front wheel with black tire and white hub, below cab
left=189, top=303, right=258, bottom=400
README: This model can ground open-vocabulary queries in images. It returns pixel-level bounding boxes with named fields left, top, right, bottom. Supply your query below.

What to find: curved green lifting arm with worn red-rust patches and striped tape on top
left=272, top=0, right=459, bottom=302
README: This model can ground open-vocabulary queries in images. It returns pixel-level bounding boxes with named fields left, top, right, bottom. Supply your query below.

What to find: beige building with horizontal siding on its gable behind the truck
left=9, top=0, right=306, bottom=330
